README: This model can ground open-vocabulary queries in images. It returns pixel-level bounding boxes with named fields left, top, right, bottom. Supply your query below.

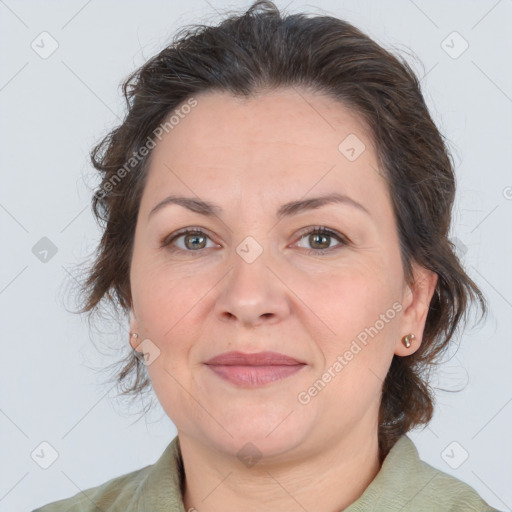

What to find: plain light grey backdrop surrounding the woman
left=0, top=0, right=512, bottom=511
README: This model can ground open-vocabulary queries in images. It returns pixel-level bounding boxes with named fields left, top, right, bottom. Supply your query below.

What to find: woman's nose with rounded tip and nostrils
left=215, top=247, right=290, bottom=328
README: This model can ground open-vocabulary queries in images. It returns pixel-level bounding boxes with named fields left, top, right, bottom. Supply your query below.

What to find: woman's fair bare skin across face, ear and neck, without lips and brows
left=130, top=88, right=437, bottom=512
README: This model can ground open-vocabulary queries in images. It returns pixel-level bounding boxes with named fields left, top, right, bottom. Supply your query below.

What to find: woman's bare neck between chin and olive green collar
left=179, top=432, right=380, bottom=512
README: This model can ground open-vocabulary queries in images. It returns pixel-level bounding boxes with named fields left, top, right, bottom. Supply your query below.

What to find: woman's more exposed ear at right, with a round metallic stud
left=395, top=262, right=439, bottom=356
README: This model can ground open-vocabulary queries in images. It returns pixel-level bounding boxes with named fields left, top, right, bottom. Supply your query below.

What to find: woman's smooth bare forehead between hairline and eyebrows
left=141, top=88, right=387, bottom=216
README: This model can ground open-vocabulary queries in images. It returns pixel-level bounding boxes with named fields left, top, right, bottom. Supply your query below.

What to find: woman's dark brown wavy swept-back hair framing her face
left=71, top=1, right=487, bottom=461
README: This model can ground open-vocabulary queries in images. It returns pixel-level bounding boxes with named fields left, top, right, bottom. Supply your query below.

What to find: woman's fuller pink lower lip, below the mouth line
left=207, top=364, right=305, bottom=388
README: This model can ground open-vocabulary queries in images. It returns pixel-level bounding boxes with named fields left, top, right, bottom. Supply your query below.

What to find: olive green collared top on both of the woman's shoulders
left=32, top=435, right=499, bottom=512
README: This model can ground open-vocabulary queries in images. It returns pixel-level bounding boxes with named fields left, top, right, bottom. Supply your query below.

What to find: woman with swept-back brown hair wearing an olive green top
left=34, top=1, right=502, bottom=512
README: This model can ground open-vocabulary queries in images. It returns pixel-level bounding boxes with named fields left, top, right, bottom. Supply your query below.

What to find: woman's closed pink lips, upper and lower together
left=205, top=352, right=306, bottom=388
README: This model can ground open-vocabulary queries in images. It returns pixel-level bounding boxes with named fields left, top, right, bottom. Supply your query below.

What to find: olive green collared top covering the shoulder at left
left=32, top=436, right=182, bottom=512
